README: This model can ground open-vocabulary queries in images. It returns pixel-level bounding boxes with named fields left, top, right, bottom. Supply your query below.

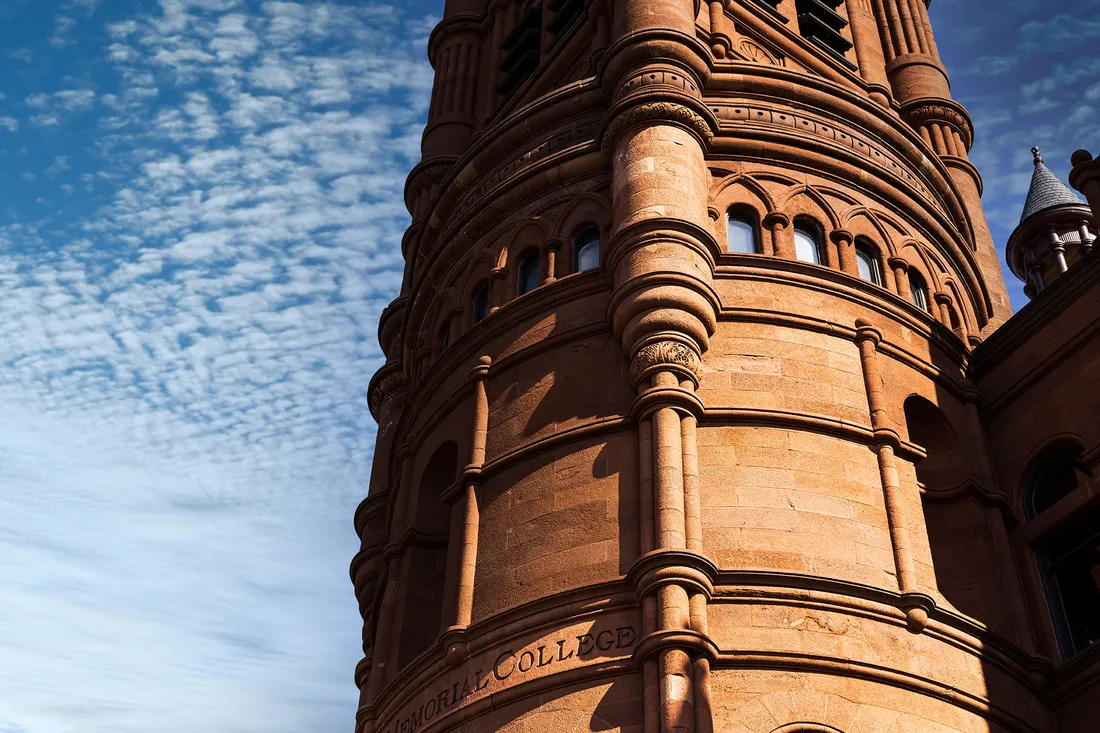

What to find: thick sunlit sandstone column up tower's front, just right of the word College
left=602, top=0, right=718, bottom=733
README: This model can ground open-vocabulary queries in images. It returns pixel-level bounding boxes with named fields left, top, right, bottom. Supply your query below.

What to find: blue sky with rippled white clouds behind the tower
left=0, top=0, right=1100, bottom=733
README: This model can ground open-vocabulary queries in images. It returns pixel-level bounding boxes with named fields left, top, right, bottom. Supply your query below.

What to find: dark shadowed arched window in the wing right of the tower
left=1024, top=444, right=1100, bottom=658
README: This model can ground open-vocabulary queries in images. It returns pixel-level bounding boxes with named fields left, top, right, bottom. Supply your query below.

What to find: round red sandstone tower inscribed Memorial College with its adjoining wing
left=351, top=0, right=1100, bottom=733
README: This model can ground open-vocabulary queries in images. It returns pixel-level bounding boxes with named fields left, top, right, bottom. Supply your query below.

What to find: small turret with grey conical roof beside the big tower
left=1007, top=147, right=1097, bottom=298
